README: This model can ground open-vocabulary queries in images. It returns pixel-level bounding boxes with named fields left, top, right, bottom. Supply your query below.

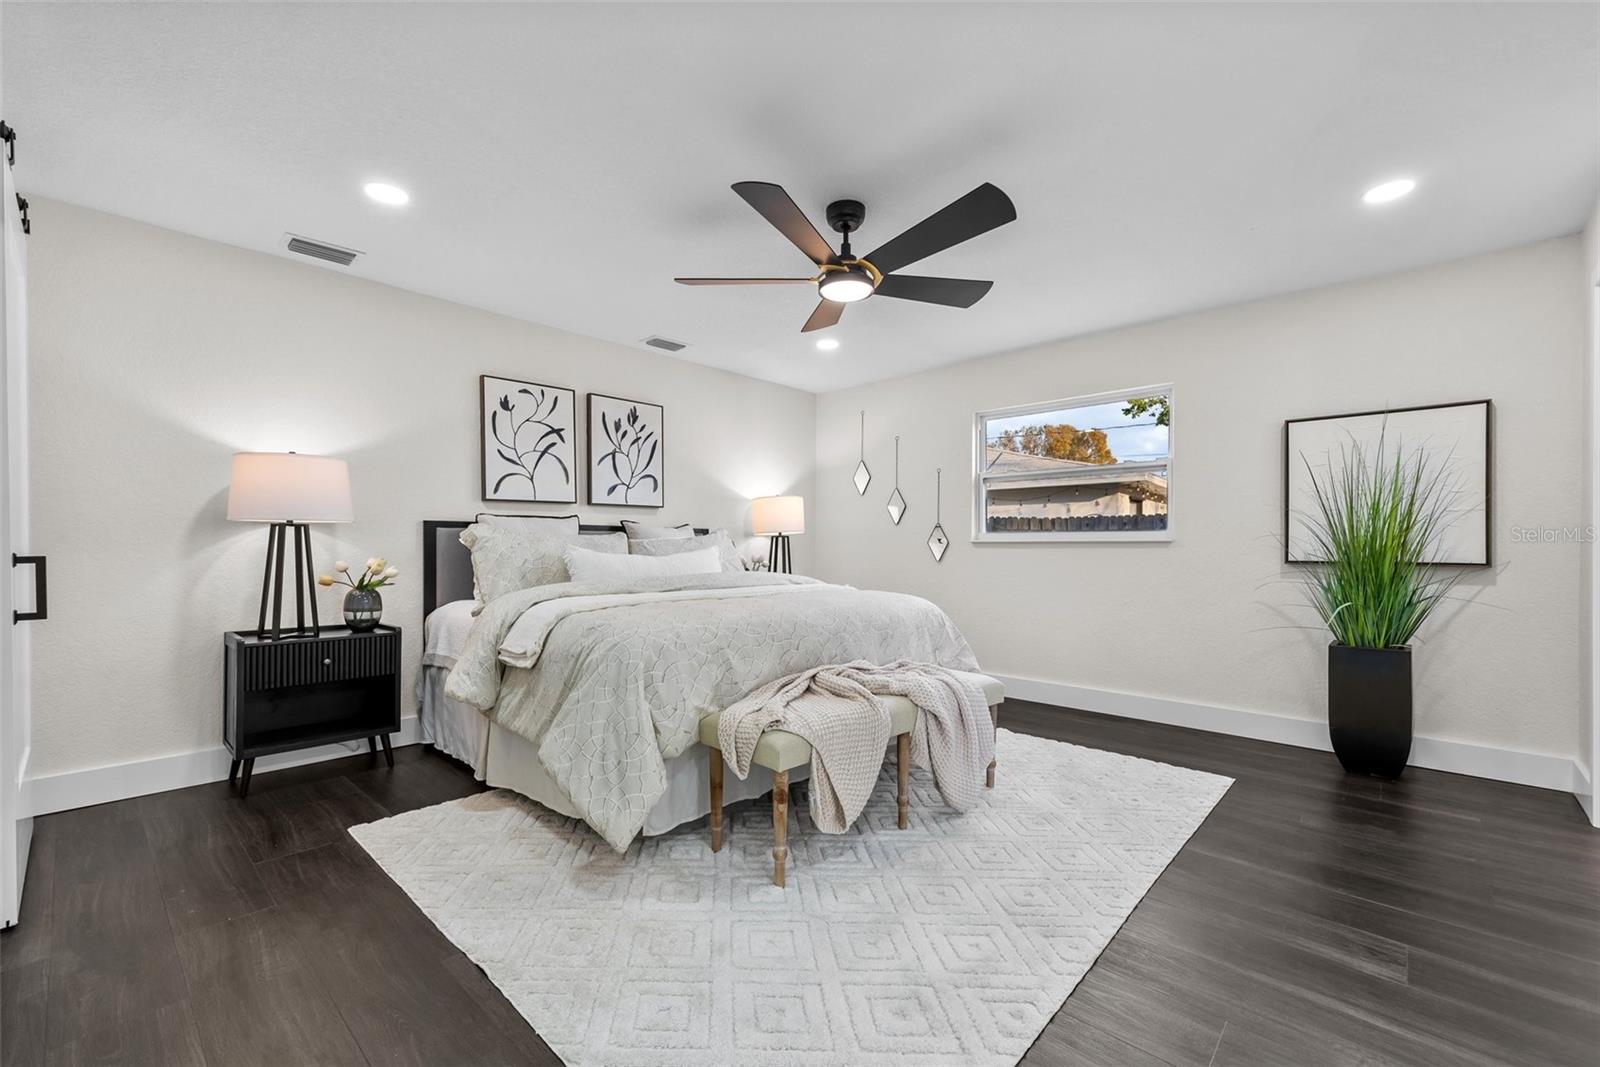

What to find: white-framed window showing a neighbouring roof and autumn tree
left=973, top=386, right=1173, bottom=541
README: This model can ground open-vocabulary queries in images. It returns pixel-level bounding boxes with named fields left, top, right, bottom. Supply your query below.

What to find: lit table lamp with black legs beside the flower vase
left=227, top=453, right=354, bottom=641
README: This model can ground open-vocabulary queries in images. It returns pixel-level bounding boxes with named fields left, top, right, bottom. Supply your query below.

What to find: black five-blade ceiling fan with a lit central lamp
left=675, top=181, right=1016, bottom=333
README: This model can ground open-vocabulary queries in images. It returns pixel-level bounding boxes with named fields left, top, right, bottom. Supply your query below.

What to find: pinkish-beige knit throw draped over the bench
left=717, top=661, right=994, bottom=833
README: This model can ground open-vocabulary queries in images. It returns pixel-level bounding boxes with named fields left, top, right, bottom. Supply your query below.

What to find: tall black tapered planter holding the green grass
left=1328, top=643, right=1411, bottom=777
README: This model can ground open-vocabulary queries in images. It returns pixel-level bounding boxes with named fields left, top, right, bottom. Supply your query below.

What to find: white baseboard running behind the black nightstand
left=22, top=715, right=419, bottom=816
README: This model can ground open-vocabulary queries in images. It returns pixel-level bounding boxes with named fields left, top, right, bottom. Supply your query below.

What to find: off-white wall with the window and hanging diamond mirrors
left=808, top=237, right=1586, bottom=787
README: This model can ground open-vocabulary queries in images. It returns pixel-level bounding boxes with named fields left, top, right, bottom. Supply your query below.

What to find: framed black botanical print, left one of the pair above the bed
left=478, top=374, right=578, bottom=504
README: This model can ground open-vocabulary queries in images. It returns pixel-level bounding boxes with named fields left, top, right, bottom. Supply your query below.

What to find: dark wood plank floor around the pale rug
left=0, top=701, right=1600, bottom=1067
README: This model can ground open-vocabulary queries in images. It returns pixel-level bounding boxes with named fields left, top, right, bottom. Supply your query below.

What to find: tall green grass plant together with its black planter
left=1301, top=437, right=1459, bottom=779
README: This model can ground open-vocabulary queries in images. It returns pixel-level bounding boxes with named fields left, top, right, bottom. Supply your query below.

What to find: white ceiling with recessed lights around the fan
left=0, top=3, right=1600, bottom=390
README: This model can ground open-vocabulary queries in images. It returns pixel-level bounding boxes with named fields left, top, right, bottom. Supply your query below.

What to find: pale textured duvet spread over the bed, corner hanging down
left=445, top=574, right=978, bottom=851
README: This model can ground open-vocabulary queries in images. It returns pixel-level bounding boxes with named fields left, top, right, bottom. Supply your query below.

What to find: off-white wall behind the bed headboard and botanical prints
left=29, top=200, right=816, bottom=787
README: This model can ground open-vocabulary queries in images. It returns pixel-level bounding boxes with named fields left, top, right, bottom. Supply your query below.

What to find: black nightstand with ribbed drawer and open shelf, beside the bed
left=222, top=625, right=400, bottom=797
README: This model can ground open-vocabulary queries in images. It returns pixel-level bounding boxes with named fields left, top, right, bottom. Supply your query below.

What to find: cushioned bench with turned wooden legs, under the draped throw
left=699, top=672, right=1005, bottom=886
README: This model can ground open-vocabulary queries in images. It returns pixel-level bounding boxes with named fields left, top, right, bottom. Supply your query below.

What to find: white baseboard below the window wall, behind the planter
left=995, top=675, right=1587, bottom=800
